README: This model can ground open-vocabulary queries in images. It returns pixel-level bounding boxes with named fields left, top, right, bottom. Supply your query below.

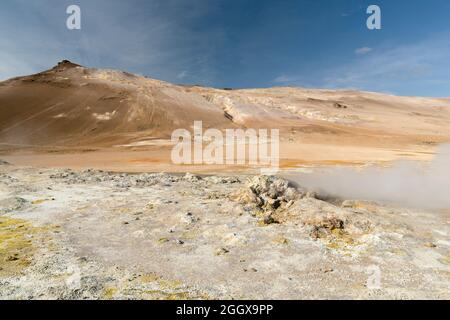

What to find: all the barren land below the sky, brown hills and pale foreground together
left=0, top=61, right=450, bottom=300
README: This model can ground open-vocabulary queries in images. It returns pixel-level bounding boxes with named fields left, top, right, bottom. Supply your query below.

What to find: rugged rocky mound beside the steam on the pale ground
left=235, top=176, right=372, bottom=242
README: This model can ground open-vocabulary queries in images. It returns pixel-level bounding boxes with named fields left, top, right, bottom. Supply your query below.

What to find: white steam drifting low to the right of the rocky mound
left=289, top=145, right=450, bottom=209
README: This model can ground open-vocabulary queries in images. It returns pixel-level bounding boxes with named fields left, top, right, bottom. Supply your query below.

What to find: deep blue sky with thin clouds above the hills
left=0, top=0, right=450, bottom=97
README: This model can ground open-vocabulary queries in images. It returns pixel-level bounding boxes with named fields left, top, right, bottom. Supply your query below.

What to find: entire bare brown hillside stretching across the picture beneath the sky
left=0, top=61, right=450, bottom=170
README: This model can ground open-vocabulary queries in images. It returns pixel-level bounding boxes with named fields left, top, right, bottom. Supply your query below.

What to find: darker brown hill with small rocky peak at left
left=0, top=61, right=237, bottom=146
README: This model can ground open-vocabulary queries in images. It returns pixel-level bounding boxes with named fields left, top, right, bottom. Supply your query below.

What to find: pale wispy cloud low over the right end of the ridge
left=323, top=33, right=450, bottom=95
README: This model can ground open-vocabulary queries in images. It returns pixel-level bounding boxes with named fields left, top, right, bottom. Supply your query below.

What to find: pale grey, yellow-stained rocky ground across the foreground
left=0, top=164, right=450, bottom=299
